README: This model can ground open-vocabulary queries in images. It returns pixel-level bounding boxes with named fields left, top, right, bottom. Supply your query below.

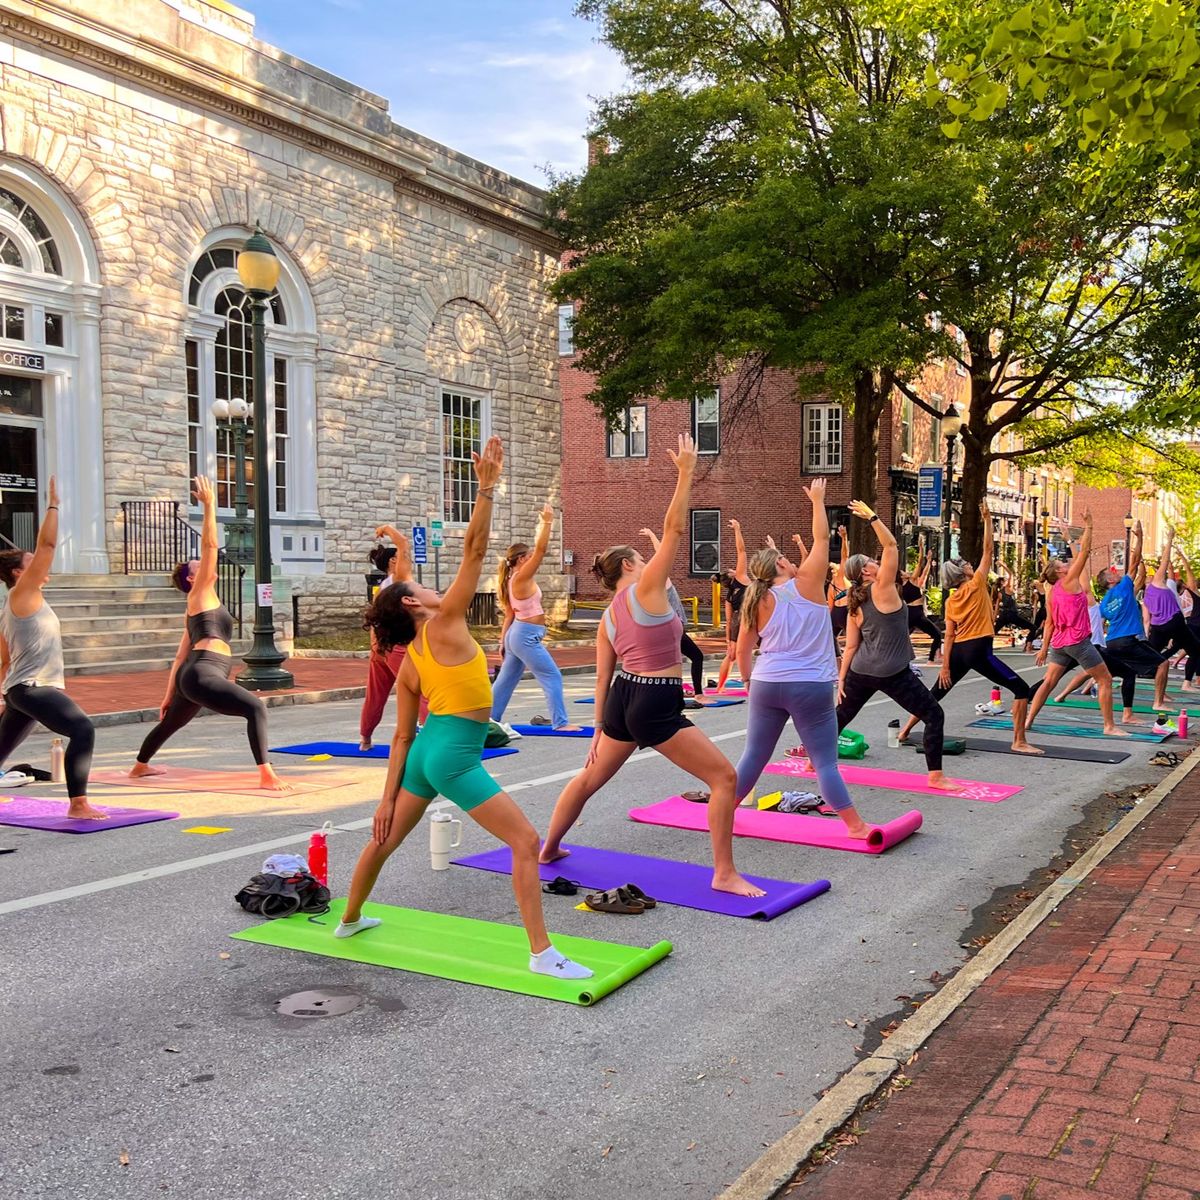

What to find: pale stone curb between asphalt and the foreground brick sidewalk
left=718, top=750, right=1200, bottom=1200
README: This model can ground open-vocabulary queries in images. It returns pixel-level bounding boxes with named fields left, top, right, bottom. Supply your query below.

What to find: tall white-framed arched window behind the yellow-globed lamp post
left=185, top=230, right=324, bottom=563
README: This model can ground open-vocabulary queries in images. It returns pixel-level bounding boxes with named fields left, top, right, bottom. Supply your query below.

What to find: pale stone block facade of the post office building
left=0, top=0, right=562, bottom=626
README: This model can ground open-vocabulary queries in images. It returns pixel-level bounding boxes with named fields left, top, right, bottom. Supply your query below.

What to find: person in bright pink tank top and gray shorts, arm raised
left=1025, top=512, right=1129, bottom=738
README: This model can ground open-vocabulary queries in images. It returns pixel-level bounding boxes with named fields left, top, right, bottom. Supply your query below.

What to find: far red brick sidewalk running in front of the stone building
left=58, top=637, right=725, bottom=716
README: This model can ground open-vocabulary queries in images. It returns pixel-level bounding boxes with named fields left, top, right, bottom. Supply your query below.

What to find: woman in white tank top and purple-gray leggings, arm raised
left=737, top=479, right=871, bottom=838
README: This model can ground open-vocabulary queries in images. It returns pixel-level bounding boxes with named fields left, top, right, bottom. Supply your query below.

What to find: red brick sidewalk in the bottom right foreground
left=781, top=770, right=1200, bottom=1200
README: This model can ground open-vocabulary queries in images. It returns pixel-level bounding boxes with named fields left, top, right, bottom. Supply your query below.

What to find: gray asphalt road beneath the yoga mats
left=0, top=656, right=1156, bottom=1200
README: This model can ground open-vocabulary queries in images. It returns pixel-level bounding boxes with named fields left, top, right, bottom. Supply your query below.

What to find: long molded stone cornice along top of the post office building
left=0, top=0, right=562, bottom=254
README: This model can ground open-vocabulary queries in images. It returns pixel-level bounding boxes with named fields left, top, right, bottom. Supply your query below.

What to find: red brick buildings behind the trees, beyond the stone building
left=558, top=305, right=1070, bottom=612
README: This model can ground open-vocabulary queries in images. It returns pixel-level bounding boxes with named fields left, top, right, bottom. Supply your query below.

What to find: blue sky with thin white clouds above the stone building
left=249, top=0, right=625, bottom=187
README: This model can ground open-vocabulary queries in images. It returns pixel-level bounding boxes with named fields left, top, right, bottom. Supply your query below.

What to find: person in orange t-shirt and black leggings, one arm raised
left=900, top=503, right=1042, bottom=754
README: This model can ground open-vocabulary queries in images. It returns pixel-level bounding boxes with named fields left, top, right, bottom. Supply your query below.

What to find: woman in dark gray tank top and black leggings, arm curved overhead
left=838, top=500, right=959, bottom=792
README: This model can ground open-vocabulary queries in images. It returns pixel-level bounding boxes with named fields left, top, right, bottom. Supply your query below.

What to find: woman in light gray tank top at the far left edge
left=0, top=476, right=99, bottom=821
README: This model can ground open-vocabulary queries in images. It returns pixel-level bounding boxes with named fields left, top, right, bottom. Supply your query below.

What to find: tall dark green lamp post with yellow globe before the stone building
left=238, top=222, right=295, bottom=691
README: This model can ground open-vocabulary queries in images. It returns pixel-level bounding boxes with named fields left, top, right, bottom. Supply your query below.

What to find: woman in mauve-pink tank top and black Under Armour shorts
left=541, top=433, right=763, bottom=896
